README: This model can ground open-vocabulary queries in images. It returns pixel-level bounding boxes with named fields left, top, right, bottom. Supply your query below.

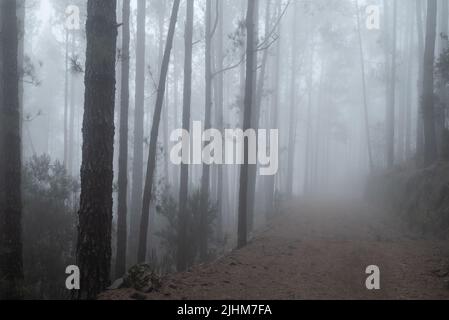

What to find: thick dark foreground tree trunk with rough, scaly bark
left=76, top=0, right=117, bottom=299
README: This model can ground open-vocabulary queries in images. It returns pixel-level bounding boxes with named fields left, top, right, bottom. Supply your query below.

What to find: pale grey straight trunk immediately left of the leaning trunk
left=129, top=0, right=146, bottom=264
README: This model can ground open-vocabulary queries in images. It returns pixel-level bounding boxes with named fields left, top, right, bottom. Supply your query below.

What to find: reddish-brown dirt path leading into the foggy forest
left=100, top=201, right=449, bottom=300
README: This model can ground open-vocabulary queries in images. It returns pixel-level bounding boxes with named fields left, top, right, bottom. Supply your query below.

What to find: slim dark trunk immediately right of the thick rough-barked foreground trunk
left=115, top=0, right=131, bottom=277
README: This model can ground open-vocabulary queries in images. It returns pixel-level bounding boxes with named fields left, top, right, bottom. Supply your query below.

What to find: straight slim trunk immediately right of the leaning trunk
left=176, top=0, right=195, bottom=271
